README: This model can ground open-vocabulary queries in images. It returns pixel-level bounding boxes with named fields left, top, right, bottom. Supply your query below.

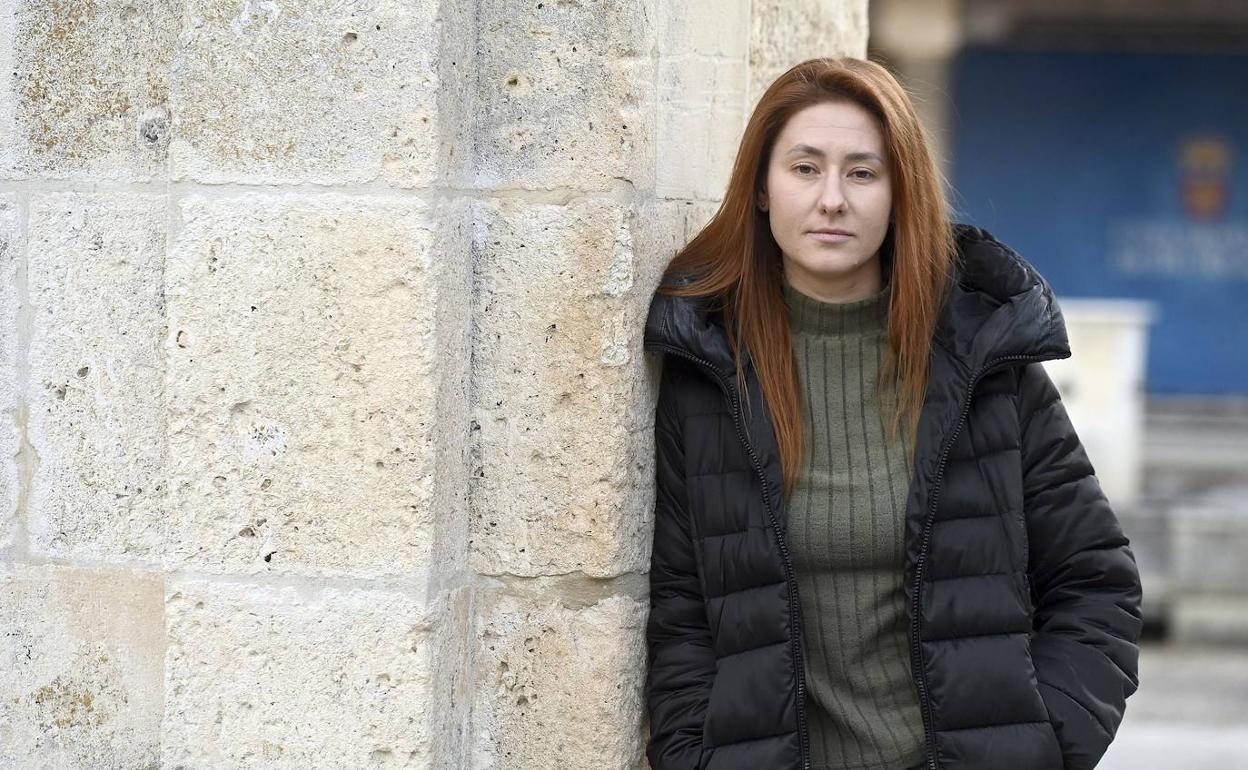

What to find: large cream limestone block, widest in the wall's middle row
left=166, top=195, right=470, bottom=577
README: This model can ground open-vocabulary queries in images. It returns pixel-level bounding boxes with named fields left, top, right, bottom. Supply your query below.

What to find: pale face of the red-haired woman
left=759, top=101, right=892, bottom=302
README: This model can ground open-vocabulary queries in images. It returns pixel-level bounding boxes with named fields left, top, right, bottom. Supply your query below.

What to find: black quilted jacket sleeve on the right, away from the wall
left=1018, top=362, right=1143, bottom=770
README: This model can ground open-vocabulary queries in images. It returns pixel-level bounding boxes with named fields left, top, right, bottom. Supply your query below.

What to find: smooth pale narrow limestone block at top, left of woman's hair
left=654, top=0, right=750, bottom=200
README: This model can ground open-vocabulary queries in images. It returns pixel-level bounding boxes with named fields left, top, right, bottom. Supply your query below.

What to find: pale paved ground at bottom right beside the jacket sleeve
left=1097, top=643, right=1248, bottom=770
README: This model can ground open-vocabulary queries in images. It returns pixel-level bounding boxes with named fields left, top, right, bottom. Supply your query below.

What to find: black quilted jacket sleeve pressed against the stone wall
left=645, top=361, right=715, bottom=770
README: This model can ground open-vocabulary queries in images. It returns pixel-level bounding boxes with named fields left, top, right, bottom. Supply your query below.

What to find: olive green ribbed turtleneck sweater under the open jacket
left=784, top=275, right=924, bottom=770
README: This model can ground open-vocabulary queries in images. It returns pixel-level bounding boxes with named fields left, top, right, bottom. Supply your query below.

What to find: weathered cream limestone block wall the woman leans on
left=0, top=0, right=866, bottom=770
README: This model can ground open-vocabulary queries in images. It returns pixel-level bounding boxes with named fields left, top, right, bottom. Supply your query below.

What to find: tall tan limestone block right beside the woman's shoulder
left=472, top=198, right=706, bottom=577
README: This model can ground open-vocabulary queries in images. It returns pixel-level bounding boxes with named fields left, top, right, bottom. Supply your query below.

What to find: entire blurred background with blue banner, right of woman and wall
left=869, top=0, right=1248, bottom=770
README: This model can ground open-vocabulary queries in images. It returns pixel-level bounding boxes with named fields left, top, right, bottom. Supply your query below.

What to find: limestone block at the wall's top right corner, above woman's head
left=748, top=0, right=867, bottom=110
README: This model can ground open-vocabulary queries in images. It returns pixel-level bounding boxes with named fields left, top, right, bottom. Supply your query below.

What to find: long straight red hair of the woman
left=658, top=57, right=957, bottom=494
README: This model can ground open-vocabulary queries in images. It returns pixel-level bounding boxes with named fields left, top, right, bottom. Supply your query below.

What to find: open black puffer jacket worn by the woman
left=645, top=225, right=1142, bottom=770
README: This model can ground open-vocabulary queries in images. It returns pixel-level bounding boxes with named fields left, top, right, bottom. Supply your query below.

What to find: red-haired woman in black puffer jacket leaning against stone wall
left=645, top=59, right=1142, bottom=770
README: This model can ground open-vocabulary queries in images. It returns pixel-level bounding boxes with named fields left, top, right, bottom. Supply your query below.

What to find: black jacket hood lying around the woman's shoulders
left=644, top=222, right=1071, bottom=376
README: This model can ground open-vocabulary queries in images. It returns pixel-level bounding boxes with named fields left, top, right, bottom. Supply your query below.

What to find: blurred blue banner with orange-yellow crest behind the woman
left=951, top=49, right=1248, bottom=396
